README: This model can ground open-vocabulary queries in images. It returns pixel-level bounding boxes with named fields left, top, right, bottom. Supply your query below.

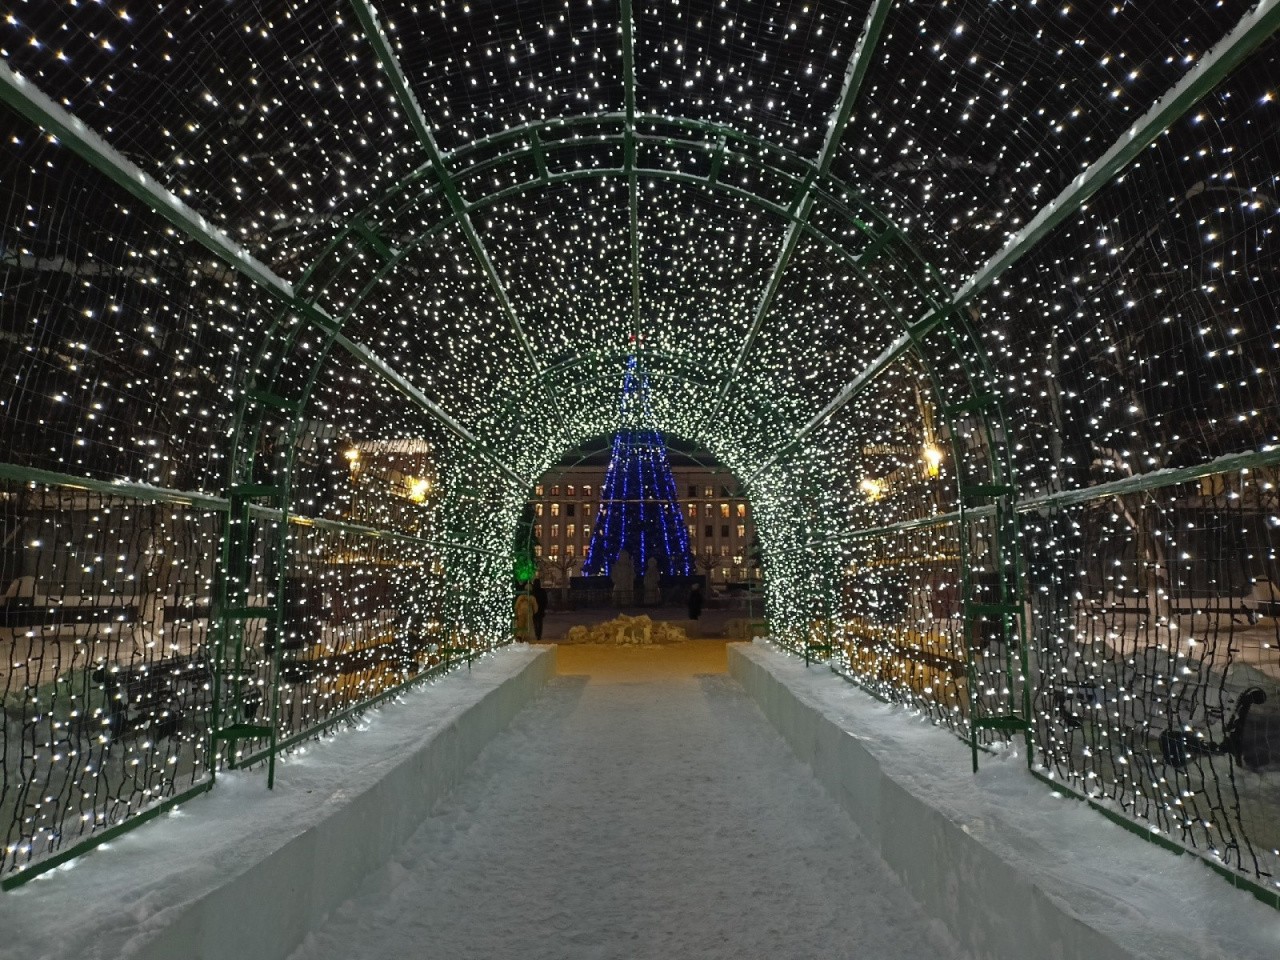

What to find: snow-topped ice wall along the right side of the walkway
left=728, top=643, right=1280, bottom=960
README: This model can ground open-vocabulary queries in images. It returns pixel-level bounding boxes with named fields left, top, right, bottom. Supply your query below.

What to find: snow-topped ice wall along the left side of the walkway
left=0, top=644, right=554, bottom=960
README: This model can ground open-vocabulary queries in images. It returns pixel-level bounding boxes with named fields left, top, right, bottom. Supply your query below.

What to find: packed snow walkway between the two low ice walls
left=293, top=641, right=963, bottom=960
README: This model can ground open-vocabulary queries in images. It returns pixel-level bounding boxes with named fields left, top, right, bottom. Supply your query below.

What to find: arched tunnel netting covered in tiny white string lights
left=0, top=0, right=1280, bottom=897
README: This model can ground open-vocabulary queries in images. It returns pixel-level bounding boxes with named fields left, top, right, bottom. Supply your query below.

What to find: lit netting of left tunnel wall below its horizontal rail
left=0, top=466, right=477, bottom=886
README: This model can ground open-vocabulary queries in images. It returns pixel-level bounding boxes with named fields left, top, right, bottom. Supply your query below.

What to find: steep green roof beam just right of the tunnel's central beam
left=701, top=0, right=893, bottom=422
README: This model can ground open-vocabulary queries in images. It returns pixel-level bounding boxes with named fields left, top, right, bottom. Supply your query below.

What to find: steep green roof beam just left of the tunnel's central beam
left=351, top=0, right=563, bottom=422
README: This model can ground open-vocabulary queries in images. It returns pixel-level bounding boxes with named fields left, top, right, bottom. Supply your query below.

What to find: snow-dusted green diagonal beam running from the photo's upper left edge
left=0, top=63, right=524, bottom=483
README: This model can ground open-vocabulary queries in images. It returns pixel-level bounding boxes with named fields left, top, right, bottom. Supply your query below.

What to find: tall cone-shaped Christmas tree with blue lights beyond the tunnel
left=582, top=356, right=694, bottom=576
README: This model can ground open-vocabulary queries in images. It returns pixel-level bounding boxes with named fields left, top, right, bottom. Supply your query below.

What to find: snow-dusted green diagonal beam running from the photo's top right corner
left=768, top=0, right=1280, bottom=478
